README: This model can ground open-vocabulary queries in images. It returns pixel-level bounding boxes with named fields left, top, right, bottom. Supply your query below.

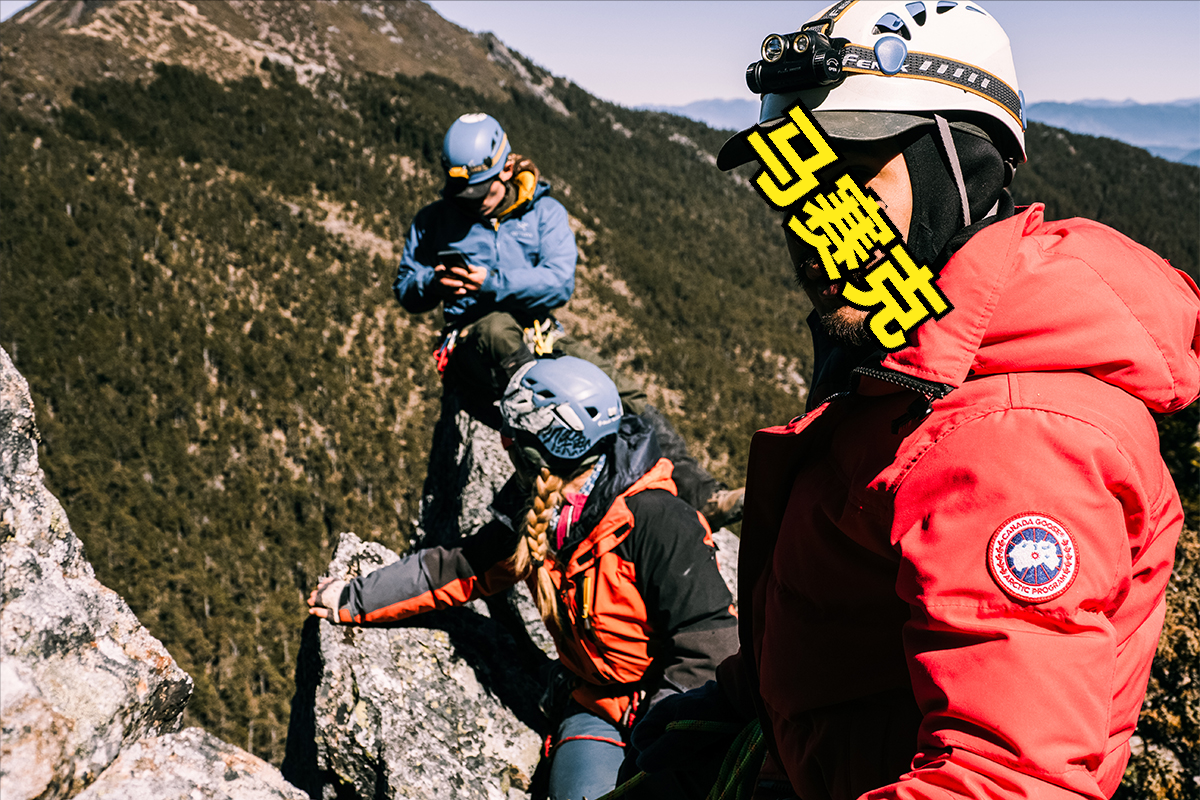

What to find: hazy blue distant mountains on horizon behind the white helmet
left=642, top=97, right=1200, bottom=166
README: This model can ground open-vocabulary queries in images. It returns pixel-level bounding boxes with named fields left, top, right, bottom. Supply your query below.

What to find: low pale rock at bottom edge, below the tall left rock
left=77, top=728, right=308, bottom=800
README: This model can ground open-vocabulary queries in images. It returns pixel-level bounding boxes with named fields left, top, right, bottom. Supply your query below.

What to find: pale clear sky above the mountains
left=0, top=0, right=1200, bottom=106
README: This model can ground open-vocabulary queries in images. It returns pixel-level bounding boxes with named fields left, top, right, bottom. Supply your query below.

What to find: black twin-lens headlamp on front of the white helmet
left=746, top=30, right=848, bottom=95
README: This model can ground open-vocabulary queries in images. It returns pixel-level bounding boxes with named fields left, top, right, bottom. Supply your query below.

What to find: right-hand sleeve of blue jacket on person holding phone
left=480, top=197, right=578, bottom=312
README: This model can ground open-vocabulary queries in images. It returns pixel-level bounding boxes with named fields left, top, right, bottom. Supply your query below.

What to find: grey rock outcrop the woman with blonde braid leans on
left=283, top=398, right=738, bottom=800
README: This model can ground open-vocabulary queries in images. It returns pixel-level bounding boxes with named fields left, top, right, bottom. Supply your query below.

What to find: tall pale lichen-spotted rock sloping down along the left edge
left=0, top=350, right=192, bottom=800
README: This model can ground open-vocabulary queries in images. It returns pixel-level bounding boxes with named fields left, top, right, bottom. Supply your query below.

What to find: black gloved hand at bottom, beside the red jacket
left=629, top=680, right=746, bottom=772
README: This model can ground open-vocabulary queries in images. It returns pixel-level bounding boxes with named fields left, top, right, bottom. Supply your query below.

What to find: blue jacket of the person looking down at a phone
left=392, top=182, right=576, bottom=327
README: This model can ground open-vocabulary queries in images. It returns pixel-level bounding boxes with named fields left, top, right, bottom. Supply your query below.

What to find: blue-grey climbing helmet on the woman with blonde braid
left=500, top=355, right=623, bottom=475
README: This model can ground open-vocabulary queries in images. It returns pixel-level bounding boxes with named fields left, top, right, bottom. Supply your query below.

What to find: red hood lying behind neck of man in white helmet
left=881, top=204, right=1200, bottom=413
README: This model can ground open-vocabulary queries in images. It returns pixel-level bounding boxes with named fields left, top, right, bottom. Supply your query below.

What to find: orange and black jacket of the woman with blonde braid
left=338, top=415, right=737, bottom=724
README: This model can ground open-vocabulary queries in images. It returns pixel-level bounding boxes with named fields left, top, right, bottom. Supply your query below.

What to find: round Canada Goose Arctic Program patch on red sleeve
left=988, top=513, right=1079, bottom=603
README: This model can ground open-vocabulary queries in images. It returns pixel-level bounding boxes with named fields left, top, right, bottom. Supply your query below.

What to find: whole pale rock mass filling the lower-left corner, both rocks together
left=0, top=350, right=306, bottom=800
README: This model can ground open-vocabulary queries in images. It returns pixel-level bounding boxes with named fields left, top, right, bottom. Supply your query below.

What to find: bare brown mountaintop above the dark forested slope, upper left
left=2, top=0, right=568, bottom=114
